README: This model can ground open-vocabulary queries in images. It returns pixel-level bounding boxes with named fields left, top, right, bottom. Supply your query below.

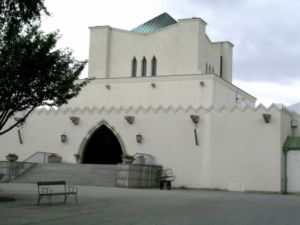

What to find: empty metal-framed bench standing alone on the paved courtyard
left=37, top=181, right=78, bottom=205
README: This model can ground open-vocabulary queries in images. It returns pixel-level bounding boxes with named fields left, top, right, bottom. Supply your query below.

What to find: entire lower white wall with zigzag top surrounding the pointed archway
left=0, top=104, right=288, bottom=192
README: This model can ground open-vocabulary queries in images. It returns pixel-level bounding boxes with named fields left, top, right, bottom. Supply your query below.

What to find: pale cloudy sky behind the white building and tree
left=42, top=0, right=300, bottom=106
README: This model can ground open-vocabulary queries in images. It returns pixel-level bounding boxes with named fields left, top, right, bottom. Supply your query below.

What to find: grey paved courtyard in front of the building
left=0, top=184, right=300, bottom=225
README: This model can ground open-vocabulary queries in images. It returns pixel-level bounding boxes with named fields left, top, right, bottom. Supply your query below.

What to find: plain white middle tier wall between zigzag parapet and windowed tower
left=65, top=75, right=256, bottom=108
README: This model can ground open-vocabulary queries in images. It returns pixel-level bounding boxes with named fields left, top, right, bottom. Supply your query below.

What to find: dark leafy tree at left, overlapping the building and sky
left=0, top=0, right=88, bottom=135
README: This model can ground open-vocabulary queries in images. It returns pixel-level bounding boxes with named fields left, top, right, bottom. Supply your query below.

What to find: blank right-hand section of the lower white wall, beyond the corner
left=211, top=107, right=282, bottom=192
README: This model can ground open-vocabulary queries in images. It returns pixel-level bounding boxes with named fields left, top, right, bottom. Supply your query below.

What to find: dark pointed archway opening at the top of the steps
left=82, top=125, right=123, bottom=164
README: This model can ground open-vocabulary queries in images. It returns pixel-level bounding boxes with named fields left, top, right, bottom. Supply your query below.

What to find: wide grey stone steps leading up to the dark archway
left=12, top=163, right=117, bottom=187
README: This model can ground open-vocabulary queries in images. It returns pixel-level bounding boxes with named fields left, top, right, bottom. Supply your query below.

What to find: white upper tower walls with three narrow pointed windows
left=89, top=19, right=233, bottom=82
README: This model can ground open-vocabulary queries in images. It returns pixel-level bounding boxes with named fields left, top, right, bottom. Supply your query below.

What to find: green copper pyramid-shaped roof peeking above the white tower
left=131, top=13, right=177, bottom=34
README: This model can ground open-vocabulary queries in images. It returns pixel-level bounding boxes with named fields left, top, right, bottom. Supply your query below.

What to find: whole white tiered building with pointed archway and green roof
left=0, top=13, right=300, bottom=192
